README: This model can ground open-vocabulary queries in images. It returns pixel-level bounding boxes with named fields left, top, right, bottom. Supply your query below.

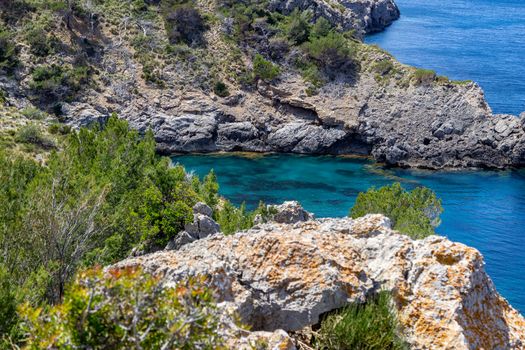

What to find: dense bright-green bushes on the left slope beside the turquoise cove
left=0, top=118, right=264, bottom=348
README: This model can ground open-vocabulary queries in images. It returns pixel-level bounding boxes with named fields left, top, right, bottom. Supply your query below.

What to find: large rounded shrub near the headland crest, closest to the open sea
left=305, top=31, right=352, bottom=68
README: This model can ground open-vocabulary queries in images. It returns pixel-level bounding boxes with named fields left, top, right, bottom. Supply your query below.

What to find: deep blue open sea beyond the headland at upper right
left=366, top=0, right=525, bottom=115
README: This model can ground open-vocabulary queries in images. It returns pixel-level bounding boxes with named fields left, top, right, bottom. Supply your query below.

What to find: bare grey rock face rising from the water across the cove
left=121, top=73, right=525, bottom=168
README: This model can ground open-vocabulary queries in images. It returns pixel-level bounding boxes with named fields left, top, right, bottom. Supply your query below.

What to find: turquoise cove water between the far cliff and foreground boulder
left=173, top=155, right=525, bottom=312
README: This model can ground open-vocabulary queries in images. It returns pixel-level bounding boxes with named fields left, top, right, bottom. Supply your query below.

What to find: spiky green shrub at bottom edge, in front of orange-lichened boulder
left=315, top=292, right=407, bottom=350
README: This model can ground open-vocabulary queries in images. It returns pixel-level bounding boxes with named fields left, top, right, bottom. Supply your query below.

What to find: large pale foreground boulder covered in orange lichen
left=112, top=215, right=525, bottom=349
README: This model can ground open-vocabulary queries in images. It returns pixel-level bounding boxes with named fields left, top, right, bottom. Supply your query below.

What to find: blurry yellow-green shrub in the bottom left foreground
left=20, top=268, right=223, bottom=349
